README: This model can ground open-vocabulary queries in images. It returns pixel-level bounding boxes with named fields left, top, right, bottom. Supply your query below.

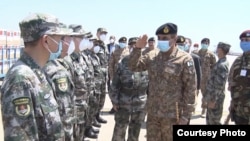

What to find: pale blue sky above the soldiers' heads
left=0, top=0, right=250, bottom=52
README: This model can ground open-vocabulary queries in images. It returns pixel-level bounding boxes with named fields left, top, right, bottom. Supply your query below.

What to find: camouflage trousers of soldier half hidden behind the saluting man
left=112, top=108, right=145, bottom=141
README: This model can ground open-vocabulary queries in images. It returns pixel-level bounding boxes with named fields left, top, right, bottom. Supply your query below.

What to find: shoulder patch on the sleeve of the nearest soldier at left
left=12, top=97, right=31, bottom=117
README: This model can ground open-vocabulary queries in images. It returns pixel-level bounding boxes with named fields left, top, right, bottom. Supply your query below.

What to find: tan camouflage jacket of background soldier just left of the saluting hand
left=108, top=46, right=129, bottom=79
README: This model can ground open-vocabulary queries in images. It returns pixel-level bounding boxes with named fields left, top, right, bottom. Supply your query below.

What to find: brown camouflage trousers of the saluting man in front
left=147, top=113, right=176, bottom=141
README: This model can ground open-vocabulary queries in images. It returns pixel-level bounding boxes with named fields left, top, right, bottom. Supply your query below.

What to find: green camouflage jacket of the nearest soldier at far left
left=1, top=53, right=64, bottom=141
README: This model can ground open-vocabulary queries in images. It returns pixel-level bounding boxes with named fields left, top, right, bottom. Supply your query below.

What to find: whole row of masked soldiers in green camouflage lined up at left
left=1, top=13, right=108, bottom=141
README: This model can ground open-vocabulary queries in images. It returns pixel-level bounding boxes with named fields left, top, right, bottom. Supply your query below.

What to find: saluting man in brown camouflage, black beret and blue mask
left=129, top=23, right=196, bottom=141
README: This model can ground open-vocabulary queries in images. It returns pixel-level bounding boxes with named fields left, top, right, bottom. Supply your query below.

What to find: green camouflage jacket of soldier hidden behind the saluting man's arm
left=109, top=56, right=148, bottom=112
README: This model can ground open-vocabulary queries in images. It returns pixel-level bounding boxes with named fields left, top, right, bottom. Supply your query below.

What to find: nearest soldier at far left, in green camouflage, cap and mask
left=1, top=13, right=65, bottom=141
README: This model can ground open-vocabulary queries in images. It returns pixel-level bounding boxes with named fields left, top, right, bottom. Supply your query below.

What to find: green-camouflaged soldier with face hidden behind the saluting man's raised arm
left=109, top=56, right=148, bottom=141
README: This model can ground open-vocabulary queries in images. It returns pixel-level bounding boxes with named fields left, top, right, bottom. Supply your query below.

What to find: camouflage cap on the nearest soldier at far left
left=19, top=13, right=68, bottom=42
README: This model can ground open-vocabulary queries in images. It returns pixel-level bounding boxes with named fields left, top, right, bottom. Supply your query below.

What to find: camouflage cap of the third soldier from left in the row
left=69, top=24, right=93, bottom=38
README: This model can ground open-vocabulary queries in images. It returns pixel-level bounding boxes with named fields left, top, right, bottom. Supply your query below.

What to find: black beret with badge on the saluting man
left=155, top=23, right=178, bottom=35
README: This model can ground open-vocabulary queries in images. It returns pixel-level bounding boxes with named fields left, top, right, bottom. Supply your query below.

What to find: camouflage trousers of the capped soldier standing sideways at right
left=206, top=94, right=225, bottom=125
